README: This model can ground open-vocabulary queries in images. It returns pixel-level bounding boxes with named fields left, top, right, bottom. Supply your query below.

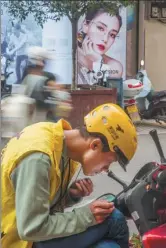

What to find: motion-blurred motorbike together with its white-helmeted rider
left=1, top=46, right=72, bottom=138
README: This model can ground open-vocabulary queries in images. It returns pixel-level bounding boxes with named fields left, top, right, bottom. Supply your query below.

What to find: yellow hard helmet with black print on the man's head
left=84, top=103, right=137, bottom=171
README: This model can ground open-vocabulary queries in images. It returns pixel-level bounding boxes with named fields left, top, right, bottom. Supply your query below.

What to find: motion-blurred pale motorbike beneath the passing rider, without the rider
left=1, top=82, right=72, bottom=138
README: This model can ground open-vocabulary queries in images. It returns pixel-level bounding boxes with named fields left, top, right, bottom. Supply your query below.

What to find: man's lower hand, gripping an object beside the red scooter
left=90, top=200, right=115, bottom=224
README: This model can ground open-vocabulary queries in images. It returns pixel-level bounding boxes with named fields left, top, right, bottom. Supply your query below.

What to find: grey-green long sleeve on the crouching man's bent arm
left=11, top=152, right=96, bottom=242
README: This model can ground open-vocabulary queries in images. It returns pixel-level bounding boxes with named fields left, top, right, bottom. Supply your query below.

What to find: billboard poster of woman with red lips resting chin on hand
left=77, top=8, right=126, bottom=84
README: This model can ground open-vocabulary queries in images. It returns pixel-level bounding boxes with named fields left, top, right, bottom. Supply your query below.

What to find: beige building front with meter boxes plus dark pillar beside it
left=126, top=0, right=166, bottom=91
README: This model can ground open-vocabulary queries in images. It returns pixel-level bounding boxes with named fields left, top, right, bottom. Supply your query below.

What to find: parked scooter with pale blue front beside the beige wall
left=136, top=60, right=166, bottom=122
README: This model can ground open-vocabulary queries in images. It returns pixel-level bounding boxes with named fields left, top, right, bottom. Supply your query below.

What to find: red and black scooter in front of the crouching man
left=69, top=130, right=166, bottom=248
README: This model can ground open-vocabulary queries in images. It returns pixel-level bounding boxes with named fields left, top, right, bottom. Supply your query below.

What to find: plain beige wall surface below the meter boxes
left=145, top=20, right=166, bottom=90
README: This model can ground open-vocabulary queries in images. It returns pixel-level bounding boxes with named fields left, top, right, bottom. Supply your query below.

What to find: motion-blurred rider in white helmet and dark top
left=22, top=46, right=70, bottom=121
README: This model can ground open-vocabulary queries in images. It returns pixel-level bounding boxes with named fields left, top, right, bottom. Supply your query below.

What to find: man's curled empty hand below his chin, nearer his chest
left=69, top=178, right=93, bottom=198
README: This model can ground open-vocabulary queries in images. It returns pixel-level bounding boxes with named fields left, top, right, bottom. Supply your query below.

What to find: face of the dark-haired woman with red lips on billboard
left=83, top=13, right=120, bottom=55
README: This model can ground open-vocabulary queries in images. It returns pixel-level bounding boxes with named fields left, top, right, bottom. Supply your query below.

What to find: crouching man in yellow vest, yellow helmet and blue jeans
left=1, top=103, right=137, bottom=248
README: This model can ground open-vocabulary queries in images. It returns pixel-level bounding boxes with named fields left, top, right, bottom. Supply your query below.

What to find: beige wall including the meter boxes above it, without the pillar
left=144, top=0, right=166, bottom=90
